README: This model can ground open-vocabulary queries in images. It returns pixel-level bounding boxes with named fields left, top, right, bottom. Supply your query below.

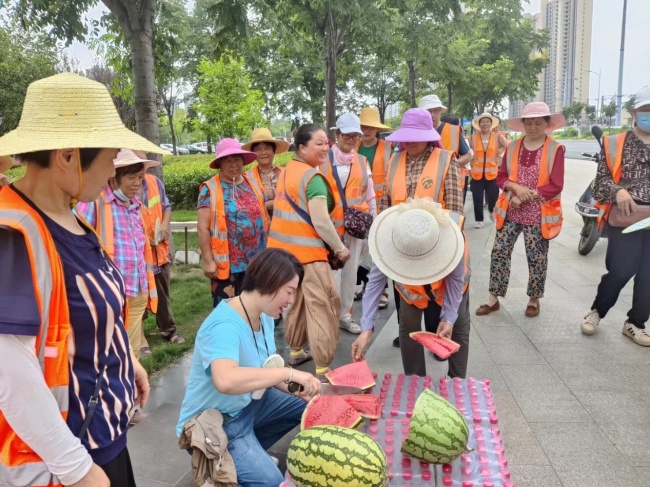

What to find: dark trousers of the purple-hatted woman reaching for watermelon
left=399, top=290, right=470, bottom=378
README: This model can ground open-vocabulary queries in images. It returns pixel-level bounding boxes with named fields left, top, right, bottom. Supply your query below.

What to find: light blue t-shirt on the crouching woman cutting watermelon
left=176, top=300, right=275, bottom=436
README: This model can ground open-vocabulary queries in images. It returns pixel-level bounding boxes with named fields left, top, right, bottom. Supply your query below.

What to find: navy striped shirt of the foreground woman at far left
left=0, top=188, right=134, bottom=465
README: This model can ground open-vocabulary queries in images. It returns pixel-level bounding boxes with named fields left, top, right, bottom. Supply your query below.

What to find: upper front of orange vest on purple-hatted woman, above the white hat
left=386, top=149, right=453, bottom=208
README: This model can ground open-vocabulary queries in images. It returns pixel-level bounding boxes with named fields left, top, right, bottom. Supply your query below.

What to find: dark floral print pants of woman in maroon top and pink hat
left=490, top=220, right=548, bottom=298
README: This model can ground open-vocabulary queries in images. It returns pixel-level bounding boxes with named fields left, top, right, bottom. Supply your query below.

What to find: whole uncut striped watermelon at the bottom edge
left=287, top=426, right=388, bottom=487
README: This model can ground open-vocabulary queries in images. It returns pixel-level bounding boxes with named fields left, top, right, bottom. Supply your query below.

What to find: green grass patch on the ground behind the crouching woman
left=141, top=265, right=212, bottom=374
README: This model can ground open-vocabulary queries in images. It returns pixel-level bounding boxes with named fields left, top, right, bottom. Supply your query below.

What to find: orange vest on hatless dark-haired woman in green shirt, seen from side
left=266, top=159, right=344, bottom=264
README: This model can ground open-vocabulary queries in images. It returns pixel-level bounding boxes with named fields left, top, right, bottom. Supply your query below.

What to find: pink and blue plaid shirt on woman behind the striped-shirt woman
left=77, top=186, right=149, bottom=297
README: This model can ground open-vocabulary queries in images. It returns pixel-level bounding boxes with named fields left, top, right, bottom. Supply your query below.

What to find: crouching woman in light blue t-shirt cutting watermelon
left=176, top=249, right=320, bottom=487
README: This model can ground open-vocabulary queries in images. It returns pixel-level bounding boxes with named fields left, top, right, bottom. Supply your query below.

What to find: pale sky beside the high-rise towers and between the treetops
left=70, top=0, right=650, bottom=104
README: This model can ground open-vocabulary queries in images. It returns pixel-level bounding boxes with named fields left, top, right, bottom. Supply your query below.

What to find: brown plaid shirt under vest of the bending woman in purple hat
left=379, top=147, right=464, bottom=215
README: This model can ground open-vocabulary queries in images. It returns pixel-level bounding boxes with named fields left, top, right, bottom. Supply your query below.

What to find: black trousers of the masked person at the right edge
left=591, top=227, right=650, bottom=328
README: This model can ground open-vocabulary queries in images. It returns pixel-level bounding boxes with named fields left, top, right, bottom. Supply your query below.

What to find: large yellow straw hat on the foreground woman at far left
left=0, top=73, right=169, bottom=156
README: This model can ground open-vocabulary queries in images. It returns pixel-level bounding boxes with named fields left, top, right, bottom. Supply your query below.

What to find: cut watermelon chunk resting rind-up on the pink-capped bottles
left=402, top=389, right=469, bottom=463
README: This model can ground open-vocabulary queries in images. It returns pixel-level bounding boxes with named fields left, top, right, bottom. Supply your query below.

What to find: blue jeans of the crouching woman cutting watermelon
left=224, top=387, right=306, bottom=487
